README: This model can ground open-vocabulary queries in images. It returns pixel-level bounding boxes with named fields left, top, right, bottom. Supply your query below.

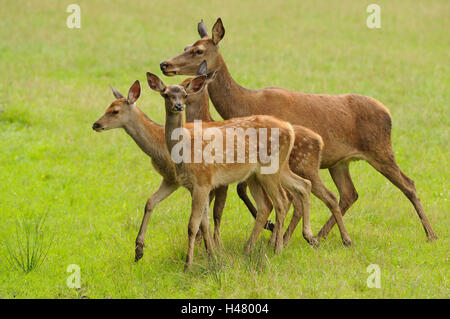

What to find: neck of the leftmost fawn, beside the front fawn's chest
left=124, top=107, right=169, bottom=163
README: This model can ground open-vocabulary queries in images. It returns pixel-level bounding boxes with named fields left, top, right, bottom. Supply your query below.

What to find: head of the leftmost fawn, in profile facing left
left=92, top=81, right=141, bottom=132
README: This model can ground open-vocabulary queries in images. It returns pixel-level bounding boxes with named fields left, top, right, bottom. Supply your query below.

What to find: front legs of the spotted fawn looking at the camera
left=184, top=187, right=212, bottom=271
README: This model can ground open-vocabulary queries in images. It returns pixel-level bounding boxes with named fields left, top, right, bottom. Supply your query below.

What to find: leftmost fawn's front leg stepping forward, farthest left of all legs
left=134, top=180, right=178, bottom=261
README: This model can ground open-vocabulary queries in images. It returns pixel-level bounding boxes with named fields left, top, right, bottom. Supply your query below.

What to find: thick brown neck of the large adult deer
left=208, top=53, right=254, bottom=119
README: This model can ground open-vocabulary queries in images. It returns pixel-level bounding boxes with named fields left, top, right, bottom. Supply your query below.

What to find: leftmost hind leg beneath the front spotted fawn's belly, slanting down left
left=244, top=177, right=273, bottom=254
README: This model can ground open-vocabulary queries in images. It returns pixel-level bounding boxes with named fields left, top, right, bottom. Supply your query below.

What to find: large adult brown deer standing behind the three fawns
left=160, top=18, right=437, bottom=240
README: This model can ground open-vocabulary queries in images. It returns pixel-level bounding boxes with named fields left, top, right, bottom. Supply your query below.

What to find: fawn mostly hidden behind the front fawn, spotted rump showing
left=185, top=61, right=351, bottom=246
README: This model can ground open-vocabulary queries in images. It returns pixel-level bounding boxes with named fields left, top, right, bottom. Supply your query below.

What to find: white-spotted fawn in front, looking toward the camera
left=147, top=73, right=317, bottom=269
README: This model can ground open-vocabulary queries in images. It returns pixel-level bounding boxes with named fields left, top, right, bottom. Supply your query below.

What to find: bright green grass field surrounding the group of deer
left=0, top=0, right=450, bottom=298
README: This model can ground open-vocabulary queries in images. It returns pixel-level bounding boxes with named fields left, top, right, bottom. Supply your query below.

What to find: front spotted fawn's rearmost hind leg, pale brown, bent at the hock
left=281, top=168, right=319, bottom=246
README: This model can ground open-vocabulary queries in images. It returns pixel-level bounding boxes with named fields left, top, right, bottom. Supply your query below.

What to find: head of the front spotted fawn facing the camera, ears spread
left=147, top=72, right=207, bottom=114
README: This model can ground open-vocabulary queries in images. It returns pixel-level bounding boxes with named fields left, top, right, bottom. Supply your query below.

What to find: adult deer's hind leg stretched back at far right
left=368, top=151, right=438, bottom=241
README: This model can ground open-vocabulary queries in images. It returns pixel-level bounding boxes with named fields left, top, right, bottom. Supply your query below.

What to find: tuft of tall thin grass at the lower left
left=5, top=214, right=53, bottom=273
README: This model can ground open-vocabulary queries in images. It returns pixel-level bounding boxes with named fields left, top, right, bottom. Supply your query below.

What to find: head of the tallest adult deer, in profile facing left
left=160, top=18, right=225, bottom=76
